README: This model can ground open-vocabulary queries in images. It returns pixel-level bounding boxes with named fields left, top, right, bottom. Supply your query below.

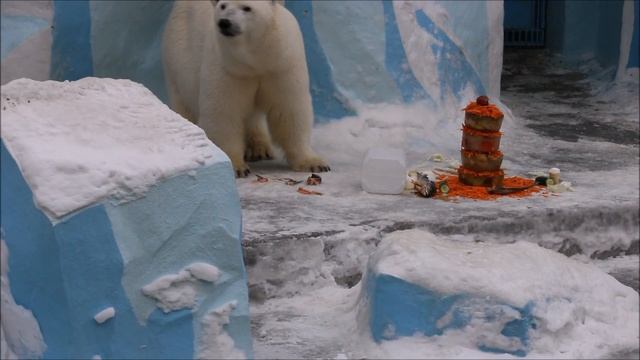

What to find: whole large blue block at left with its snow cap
left=1, top=78, right=252, bottom=358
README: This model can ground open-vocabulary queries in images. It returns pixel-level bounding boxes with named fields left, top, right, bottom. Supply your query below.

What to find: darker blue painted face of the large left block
left=0, top=143, right=194, bottom=359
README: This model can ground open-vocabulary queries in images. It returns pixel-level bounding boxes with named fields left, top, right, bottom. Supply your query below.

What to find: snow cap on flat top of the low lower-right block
left=371, top=230, right=638, bottom=308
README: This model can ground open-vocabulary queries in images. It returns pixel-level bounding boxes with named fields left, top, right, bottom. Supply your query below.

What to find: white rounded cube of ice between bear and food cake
left=362, top=147, right=407, bottom=194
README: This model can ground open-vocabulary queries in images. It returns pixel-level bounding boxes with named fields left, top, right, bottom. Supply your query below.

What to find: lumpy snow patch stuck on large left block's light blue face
left=142, top=262, right=220, bottom=313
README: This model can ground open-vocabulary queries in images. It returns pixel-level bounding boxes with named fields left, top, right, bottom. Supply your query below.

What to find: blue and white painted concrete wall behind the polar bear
left=2, top=0, right=502, bottom=121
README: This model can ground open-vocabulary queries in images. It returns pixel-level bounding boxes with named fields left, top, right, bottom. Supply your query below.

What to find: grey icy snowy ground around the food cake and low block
left=238, top=51, right=639, bottom=358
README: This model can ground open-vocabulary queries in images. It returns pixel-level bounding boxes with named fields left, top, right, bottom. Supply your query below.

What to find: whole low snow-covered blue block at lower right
left=359, top=230, right=639, bottom=358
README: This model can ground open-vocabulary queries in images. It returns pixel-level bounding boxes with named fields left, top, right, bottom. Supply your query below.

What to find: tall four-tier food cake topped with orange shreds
left=458, top=96, right=504, bottom=187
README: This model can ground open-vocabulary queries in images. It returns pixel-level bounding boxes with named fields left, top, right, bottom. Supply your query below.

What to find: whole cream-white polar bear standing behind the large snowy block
left=162, top=0, right=330, bottom=177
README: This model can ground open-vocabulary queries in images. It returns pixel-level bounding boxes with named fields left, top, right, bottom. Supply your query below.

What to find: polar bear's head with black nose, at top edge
left=213, top=0, right=283, bottom=38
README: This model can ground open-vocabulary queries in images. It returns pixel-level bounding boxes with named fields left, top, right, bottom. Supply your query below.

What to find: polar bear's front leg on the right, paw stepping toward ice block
left=259, top=75, right=330, bottom=172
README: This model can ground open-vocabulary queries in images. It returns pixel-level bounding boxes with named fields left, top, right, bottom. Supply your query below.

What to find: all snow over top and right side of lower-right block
left=364, top=230, right=640, bottom=358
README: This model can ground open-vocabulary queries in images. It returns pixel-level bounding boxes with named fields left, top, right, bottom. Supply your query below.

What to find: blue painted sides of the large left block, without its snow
left=0, top=136, right=253, bottom=359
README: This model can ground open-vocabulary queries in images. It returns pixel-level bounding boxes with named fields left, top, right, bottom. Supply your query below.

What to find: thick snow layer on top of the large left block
left=2, top=78, right=227, bottom=219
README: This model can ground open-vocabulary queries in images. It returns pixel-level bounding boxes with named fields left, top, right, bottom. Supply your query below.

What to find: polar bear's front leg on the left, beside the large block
left=198, top=76, right=257, bottom=177
